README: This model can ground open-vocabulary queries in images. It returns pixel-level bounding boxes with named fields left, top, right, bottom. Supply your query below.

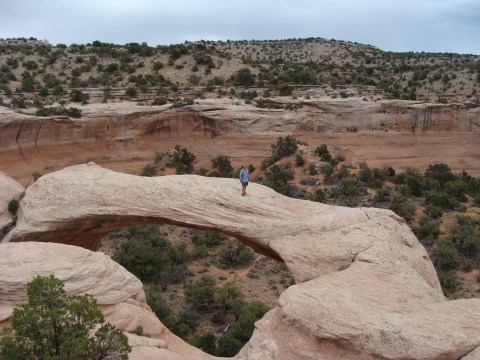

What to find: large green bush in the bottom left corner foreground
left=0, top=275, right=131, bottom=360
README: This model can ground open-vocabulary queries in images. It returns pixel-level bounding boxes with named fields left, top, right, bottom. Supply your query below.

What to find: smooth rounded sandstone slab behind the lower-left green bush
left=0, top=242, right=216, bottom=359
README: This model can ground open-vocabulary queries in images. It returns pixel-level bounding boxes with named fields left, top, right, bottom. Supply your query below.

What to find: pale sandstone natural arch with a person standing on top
left=0, top=163, right=480, bottom=360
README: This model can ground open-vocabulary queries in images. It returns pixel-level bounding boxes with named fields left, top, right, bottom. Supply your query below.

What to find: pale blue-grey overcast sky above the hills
left=0, top=0, right=480, bottom=55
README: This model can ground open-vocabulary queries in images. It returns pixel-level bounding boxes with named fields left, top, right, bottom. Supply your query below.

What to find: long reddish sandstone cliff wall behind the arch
left=0, top=94, right=480, bottom=180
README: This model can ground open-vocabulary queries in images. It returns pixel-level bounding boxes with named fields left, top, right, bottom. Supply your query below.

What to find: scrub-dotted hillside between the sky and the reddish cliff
left=0, top=38, right=480, bottom=107
